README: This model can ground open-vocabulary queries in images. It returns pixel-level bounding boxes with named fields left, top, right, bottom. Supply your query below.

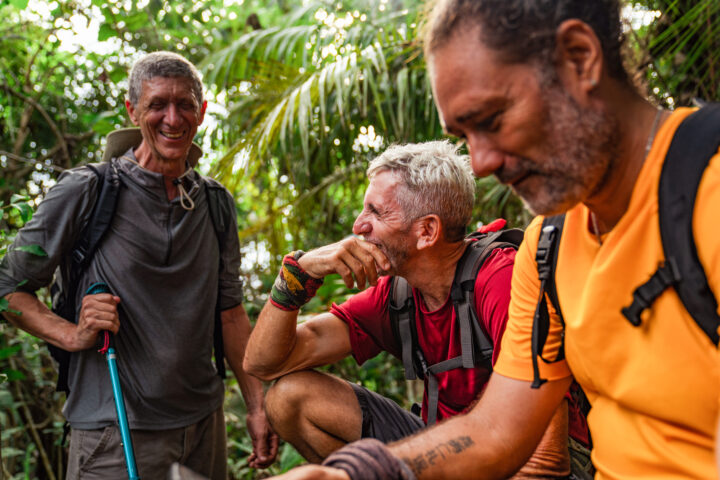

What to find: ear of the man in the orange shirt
left=555, top=19, right=604, bottom=104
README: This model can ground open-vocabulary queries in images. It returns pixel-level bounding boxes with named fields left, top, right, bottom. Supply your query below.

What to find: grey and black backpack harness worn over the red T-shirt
left=389, top=229, right=523, bottom=425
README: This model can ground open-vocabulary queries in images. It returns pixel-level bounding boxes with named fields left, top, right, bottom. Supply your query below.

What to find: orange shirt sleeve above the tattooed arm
left=495, top=217, right=571, bottom=381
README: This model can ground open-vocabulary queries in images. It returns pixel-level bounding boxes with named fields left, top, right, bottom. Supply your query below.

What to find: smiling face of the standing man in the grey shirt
left=126, top=77, right=207, bottom=167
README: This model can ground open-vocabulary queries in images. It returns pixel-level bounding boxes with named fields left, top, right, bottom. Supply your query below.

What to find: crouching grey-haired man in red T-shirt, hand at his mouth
left=244, top=141, right=569, bottom=477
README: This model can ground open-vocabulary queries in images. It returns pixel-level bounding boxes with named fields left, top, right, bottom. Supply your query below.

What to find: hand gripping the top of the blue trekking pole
left=72, top=293, right=120, bottom=351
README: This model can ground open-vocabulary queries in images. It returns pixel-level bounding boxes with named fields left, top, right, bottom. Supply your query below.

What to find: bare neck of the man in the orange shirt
left=584, top=93, right=667, bottom=233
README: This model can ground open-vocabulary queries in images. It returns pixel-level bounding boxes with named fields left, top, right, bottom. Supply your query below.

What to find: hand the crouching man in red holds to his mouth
left=298, top=237, right=391, bottom=289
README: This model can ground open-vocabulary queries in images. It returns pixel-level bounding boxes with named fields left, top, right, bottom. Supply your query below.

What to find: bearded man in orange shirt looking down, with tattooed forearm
left=264, top=0, right=720, bottom=480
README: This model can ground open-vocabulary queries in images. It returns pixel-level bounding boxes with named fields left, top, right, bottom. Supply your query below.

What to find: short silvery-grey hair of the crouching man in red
left=367, top=140, right=475, bottom=242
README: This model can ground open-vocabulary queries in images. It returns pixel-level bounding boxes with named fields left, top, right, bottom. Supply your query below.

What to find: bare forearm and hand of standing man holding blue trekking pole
left=5, top=292, right=120, bottom=352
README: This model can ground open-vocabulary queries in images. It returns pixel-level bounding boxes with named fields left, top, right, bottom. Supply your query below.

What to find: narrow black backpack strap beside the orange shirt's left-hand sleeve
left=531, top=214, right=565, bottom=388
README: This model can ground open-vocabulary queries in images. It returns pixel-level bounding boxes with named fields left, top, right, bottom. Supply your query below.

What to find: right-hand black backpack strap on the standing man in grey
left=200, top=176, right=234, bottom=378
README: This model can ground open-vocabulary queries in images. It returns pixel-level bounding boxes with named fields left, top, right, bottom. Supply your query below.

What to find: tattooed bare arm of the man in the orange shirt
left=390, top=373, right=571, bottom=479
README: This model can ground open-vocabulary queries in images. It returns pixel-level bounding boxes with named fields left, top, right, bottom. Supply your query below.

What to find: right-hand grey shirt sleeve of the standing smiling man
left=215, top=186, right=243, bottom=310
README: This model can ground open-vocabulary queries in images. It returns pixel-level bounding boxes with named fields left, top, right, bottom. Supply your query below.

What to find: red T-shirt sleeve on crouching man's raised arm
left=330, top=277, right=399, bottom=365
